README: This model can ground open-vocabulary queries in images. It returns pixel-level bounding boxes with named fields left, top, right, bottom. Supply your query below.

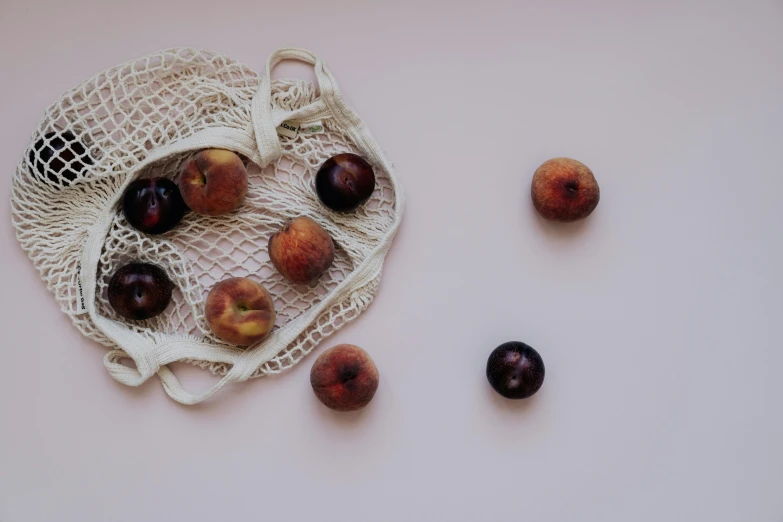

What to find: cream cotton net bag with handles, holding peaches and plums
left=11, top=48, right=403, bottom=404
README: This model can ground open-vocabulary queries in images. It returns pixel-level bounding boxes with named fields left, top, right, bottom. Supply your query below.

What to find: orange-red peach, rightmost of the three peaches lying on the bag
left=268, top=216, right=334, bottom=285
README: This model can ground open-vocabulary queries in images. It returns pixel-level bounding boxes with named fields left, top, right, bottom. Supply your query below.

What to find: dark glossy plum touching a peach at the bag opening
left=122, top=178, right=186, bottom=234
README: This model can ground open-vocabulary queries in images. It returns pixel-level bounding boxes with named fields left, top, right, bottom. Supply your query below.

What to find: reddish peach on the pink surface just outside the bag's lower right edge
left=310, top=344, right=380, bottom=411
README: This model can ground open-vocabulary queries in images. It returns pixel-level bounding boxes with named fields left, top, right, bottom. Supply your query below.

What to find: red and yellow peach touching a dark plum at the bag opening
left=178, top=149, right=247, bottom=216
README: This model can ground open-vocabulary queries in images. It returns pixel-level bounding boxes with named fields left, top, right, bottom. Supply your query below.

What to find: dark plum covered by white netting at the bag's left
left=30, top=131, right=92, bottom=187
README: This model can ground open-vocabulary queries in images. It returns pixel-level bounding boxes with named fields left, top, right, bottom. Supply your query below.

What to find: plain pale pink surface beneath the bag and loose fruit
left=0, top=0, right=783, bottom=522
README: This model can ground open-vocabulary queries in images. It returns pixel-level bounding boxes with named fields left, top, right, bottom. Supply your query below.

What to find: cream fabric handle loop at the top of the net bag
left=251, top=47, right=339, bottom=167
